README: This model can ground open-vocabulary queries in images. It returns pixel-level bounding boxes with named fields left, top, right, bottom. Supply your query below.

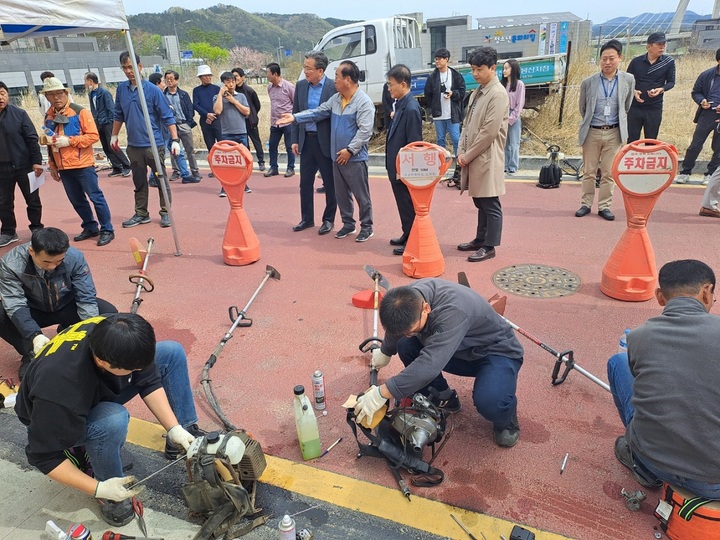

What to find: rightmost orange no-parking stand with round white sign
left=600, top=139, right=677, bottom=302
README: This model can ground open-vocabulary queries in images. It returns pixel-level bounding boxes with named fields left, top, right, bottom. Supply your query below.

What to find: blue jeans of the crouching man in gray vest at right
left=607, top=353, right=720, bottom=500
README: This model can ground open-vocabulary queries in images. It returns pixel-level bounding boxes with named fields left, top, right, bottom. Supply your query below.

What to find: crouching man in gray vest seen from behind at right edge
left=608, top=260, right=720, bottom=500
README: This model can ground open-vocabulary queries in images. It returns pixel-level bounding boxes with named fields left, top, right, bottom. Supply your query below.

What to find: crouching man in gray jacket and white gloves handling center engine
left=355, top=279, right=524, bottom=448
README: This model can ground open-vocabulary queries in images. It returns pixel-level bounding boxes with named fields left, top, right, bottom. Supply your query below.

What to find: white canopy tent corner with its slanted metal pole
left=0, top=0, right=182, bottom=255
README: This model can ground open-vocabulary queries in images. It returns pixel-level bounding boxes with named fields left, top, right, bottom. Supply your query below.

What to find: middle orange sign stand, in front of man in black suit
left=395, top=142, right=452, bottom=278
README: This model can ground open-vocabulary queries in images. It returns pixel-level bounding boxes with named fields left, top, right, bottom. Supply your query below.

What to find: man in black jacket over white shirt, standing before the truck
left=425, top=48, right=465, bottom=155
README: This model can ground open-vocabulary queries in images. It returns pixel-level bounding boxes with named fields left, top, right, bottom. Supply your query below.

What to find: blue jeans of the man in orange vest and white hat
left=60, top=167, right=113, bottom=232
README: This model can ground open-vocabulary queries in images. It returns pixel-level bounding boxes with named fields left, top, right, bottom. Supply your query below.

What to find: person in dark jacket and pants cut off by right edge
left=675, top=49, right=720, bottom=188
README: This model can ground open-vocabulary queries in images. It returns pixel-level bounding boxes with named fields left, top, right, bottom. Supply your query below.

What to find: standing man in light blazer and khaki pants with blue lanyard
left=575, top=39, right=635, bottom=221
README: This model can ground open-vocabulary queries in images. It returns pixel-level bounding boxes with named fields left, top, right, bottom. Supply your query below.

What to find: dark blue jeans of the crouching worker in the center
left=397, top=337, right=522, bottom=431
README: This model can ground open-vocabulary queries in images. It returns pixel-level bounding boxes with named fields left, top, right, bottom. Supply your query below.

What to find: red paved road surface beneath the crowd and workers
left=0, top=167, right=720, bottom=539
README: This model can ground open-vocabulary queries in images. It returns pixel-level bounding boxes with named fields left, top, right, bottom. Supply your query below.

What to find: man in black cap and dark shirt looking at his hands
left=627, top=32, right=675, bottom=143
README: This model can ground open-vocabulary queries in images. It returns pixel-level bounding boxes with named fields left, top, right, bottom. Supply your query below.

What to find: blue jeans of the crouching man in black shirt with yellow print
left=80, top=341, right=197, bottom=480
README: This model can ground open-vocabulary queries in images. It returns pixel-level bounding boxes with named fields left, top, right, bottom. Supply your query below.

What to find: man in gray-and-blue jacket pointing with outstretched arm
left=278, top=60, right=375, bottom=242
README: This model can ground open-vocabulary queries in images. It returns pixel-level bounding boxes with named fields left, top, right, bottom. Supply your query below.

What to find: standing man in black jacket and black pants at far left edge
left=0, top=81, right=43, bottom=247
